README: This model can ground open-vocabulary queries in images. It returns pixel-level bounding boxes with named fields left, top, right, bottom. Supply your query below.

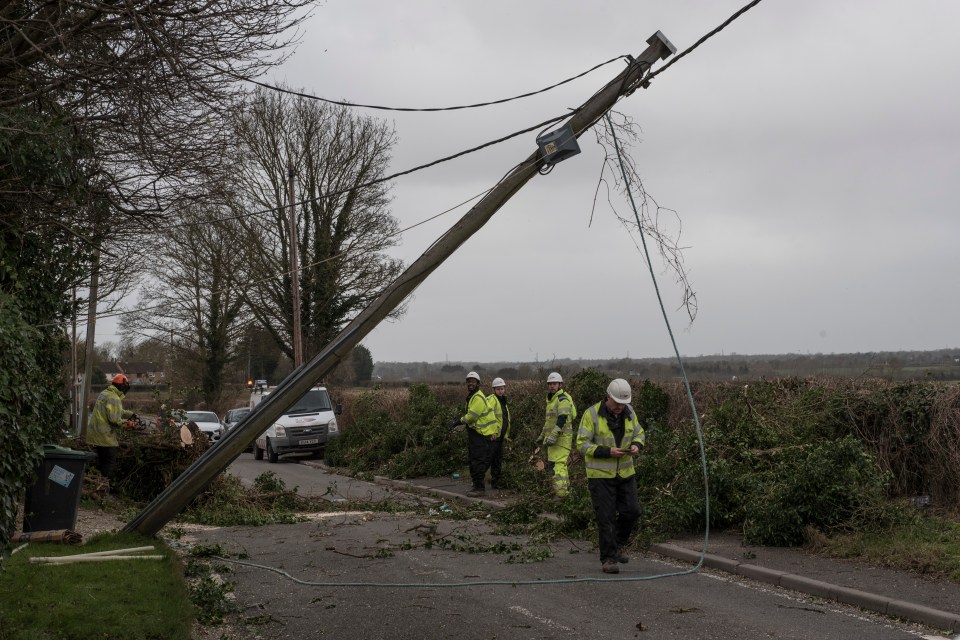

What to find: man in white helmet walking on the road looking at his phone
left=577, top=378, right=646, bottom=573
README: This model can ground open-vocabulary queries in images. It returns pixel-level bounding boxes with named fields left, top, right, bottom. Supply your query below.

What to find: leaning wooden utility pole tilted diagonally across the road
left=124, top=31, right=676, bottom=535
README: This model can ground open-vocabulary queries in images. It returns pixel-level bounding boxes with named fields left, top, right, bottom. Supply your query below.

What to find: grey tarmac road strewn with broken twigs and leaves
left=199, top=454, right=952, bottom=640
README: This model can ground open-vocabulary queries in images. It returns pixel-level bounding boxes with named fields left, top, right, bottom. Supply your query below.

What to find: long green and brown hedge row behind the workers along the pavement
left=327, top=370, right=960, bottom=545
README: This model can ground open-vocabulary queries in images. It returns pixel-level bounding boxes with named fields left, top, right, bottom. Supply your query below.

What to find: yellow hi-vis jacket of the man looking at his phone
left=577, top=402, right=647, bottom=478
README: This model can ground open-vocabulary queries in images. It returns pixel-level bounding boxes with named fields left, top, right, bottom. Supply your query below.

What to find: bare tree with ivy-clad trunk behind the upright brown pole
left=234, top=90, right=403, bottom=358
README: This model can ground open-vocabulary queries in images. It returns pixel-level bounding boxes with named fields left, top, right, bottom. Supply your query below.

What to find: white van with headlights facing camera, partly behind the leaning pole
left=250, top=387, right=340, bottom=462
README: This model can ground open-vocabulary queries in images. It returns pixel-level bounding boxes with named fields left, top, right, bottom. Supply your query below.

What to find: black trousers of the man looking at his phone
left=587, top=475, right=640, bottom=562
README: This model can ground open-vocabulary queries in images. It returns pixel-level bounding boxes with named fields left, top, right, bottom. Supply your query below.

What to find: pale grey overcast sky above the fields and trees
left=94, top=0, right=960, bottom=363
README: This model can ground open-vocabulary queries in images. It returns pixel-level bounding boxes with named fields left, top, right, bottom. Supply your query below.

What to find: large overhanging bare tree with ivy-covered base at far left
left=0, top=0, right=309, bottom=547
